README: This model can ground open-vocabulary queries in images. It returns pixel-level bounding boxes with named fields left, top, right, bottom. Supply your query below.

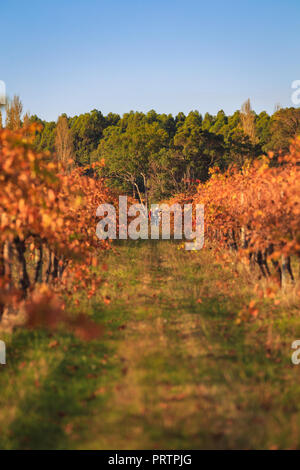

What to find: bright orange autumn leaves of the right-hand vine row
left=169, top=138, right=300, bottom=258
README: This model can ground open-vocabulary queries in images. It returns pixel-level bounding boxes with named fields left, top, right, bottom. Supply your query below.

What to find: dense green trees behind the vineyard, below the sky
left=6, top=97, right=300, bottom=202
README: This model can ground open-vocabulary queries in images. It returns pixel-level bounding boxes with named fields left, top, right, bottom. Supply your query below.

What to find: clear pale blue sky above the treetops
left=0, top=0, right=300, bottom=120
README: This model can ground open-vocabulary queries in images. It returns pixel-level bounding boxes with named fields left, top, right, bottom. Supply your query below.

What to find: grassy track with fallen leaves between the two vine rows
left=0, top=242, right=300, bottom=449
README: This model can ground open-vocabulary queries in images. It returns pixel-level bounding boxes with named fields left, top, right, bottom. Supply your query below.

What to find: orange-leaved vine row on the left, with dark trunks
left=0, top=126, right=115, bottom=335
